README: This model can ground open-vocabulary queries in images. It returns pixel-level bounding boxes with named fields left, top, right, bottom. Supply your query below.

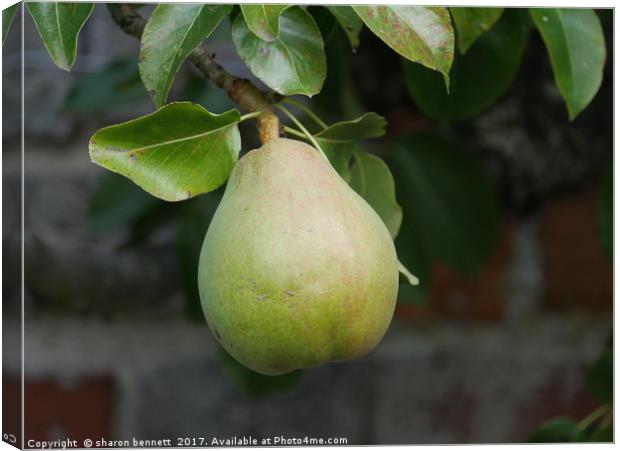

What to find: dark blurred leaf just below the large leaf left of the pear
left=87, top=172, right=160, bottom=230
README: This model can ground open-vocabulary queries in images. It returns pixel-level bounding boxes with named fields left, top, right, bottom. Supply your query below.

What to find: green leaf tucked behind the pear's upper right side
left=350, top=150, right=403, bottom=238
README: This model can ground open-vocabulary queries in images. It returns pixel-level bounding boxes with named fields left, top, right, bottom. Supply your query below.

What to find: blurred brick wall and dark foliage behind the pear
left=2, top=3, right=613, bottom=444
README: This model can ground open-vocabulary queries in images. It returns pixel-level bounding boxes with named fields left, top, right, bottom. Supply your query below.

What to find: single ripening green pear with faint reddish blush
left=198, top=138, right=398, bottom=375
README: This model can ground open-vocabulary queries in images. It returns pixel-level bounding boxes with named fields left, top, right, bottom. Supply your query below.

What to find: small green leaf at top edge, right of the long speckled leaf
left=450, top=6, right=504, bottom=53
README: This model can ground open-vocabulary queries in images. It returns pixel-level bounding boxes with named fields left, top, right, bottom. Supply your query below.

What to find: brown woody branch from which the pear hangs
left=108, top=3, right=280, bottom=144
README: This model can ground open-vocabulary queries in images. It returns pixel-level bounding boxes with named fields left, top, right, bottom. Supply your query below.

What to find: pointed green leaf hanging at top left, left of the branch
left=26, top=2, right=95, bottom=71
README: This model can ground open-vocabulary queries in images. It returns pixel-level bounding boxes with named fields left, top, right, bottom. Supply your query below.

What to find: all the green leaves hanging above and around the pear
left=3, top=2, right=611, bottom=308
